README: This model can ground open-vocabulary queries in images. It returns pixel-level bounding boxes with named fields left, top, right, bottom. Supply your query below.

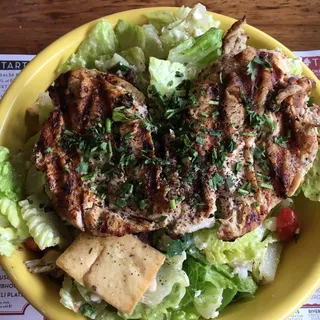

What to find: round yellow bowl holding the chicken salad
left=0, top=8, right=320, bottom=320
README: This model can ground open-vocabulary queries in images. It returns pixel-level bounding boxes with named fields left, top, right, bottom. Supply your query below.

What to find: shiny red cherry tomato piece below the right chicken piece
left=277, top=208, right=299, bottom=241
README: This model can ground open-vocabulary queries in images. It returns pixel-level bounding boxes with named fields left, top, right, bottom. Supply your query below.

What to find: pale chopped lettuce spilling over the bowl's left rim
left=0, top=93, right=70, bottom=256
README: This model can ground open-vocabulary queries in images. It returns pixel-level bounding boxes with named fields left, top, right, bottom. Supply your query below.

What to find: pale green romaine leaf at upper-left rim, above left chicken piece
left=58, top=19, right=118, bottom=74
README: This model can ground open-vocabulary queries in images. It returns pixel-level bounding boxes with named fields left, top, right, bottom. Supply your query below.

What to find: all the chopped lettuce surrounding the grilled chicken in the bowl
left=0, top=4, right=320, bottom=320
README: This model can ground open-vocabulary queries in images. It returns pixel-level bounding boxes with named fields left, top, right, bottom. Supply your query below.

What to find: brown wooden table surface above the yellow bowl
left=0, top=0, right=320, bottom=54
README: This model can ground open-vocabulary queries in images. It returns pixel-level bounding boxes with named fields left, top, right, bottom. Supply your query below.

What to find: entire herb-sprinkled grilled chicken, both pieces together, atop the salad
left=35, top=19, right=320, bottom=240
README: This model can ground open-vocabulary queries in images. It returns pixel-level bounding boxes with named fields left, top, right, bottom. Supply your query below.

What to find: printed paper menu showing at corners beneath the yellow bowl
left=0, top=50, right=320, bottom=320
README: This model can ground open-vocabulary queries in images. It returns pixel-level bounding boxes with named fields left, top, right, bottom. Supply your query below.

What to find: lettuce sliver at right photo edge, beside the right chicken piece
left=301, top=150, right=320, bottom=201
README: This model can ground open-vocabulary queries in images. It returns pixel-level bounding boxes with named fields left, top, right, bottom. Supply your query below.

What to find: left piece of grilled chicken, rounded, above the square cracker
left=35, top=69, right=214, bottom=236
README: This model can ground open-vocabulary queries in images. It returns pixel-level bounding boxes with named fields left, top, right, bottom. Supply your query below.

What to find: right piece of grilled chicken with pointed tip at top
left=189, top=19, right=320, bottom=240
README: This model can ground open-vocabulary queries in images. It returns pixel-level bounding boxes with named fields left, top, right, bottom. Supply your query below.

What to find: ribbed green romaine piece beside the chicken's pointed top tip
left=168, top=28, right=223, bottom=69
